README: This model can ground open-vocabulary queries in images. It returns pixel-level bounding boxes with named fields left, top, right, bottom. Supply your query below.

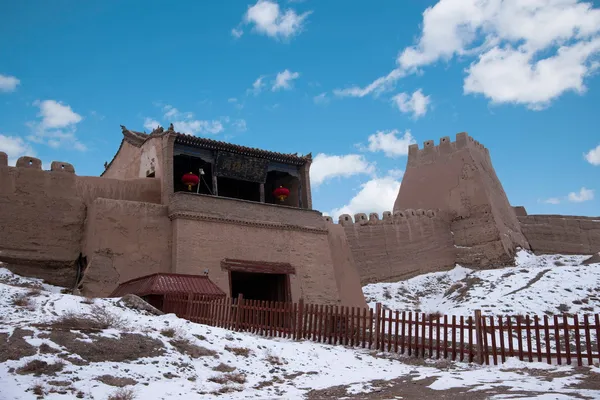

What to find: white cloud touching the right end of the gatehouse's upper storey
left=310, top=153, right=375, bottom=187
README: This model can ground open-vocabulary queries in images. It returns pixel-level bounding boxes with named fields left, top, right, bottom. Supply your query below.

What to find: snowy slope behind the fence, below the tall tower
left=363, top=250, right=600, bottom=316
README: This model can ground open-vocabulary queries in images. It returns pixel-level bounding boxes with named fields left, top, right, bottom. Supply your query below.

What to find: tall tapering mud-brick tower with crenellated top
left=394, top=132, right=529, bottom=268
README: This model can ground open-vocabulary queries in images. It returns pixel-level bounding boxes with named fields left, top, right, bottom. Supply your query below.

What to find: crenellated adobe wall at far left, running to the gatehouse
left=0, top=152, right=161, bottom=287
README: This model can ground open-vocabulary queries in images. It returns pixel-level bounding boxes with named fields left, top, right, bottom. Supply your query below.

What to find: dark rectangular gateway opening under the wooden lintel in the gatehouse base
left=230, top=271, right=291, bottom=302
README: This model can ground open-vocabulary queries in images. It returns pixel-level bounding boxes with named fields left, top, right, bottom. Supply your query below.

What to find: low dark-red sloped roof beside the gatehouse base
left=109, top=273, right=226, bottom=297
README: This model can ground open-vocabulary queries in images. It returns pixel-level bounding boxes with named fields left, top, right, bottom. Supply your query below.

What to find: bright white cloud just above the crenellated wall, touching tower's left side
left=330, top=176, right=400, bottom=221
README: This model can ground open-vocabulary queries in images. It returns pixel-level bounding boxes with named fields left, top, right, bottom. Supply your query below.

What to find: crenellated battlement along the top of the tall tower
left=407, top=132, right=490, bottom=168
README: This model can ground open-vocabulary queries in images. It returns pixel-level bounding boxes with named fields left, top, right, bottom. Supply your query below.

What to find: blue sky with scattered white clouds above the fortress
left=0, top=0, right=600, bottom=219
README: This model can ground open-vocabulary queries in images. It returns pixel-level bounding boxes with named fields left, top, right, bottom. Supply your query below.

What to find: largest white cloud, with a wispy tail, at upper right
left=337, top=0, right=600, bottom=109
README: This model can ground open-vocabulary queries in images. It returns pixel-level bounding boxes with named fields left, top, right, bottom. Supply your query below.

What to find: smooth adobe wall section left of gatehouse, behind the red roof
left=80, top=198, right=171, bottom=297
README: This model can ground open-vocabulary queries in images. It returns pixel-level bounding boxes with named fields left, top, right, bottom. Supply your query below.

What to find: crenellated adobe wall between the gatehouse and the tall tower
left=339, top=209, right=456, bottom=285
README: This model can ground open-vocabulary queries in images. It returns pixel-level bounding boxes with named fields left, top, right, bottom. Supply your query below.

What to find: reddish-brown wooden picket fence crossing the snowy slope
left=163, top=295, right=600, bottom=366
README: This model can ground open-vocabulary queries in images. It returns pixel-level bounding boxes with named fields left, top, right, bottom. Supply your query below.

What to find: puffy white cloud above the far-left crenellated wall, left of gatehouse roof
left=27, top=100, right=86, bottom=151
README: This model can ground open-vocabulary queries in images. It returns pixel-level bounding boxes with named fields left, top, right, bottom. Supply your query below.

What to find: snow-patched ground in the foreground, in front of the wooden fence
left=0, top=268, right=600, bottom=400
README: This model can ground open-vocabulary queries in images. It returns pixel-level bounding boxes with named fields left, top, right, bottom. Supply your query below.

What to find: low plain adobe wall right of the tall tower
left=519, top=215, right=600, bottom=254
